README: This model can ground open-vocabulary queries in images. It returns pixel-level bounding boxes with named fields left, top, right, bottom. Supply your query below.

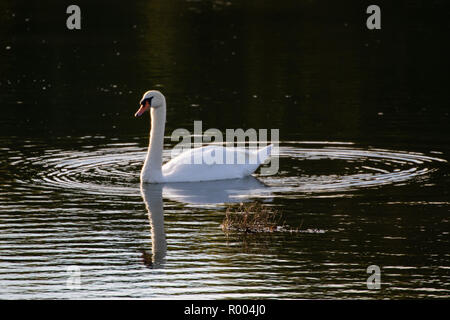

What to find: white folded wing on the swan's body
left=162, top=146, right=267, bottom=182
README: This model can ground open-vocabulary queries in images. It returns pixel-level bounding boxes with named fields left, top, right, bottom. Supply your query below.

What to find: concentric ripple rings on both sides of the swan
left=7, top=142, right=446, bottom=196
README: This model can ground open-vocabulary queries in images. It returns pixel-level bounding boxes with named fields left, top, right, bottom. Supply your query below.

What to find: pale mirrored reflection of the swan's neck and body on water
left=141, top=176, right=268, bottom=268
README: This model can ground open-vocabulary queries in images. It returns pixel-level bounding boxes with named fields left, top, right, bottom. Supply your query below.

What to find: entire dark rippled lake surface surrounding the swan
left=0, top=1, right=450, bottom=299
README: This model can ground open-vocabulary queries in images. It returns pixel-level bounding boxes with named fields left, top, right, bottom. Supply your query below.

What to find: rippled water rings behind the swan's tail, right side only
left=266, top=142, right=447, bottom=195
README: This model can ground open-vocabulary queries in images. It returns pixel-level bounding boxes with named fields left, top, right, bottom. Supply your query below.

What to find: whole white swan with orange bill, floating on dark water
left=135, top=90, right=272, bottom=183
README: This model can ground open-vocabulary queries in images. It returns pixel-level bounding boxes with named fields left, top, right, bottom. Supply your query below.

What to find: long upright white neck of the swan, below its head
left=141, top=102, right=166, bottom=182
